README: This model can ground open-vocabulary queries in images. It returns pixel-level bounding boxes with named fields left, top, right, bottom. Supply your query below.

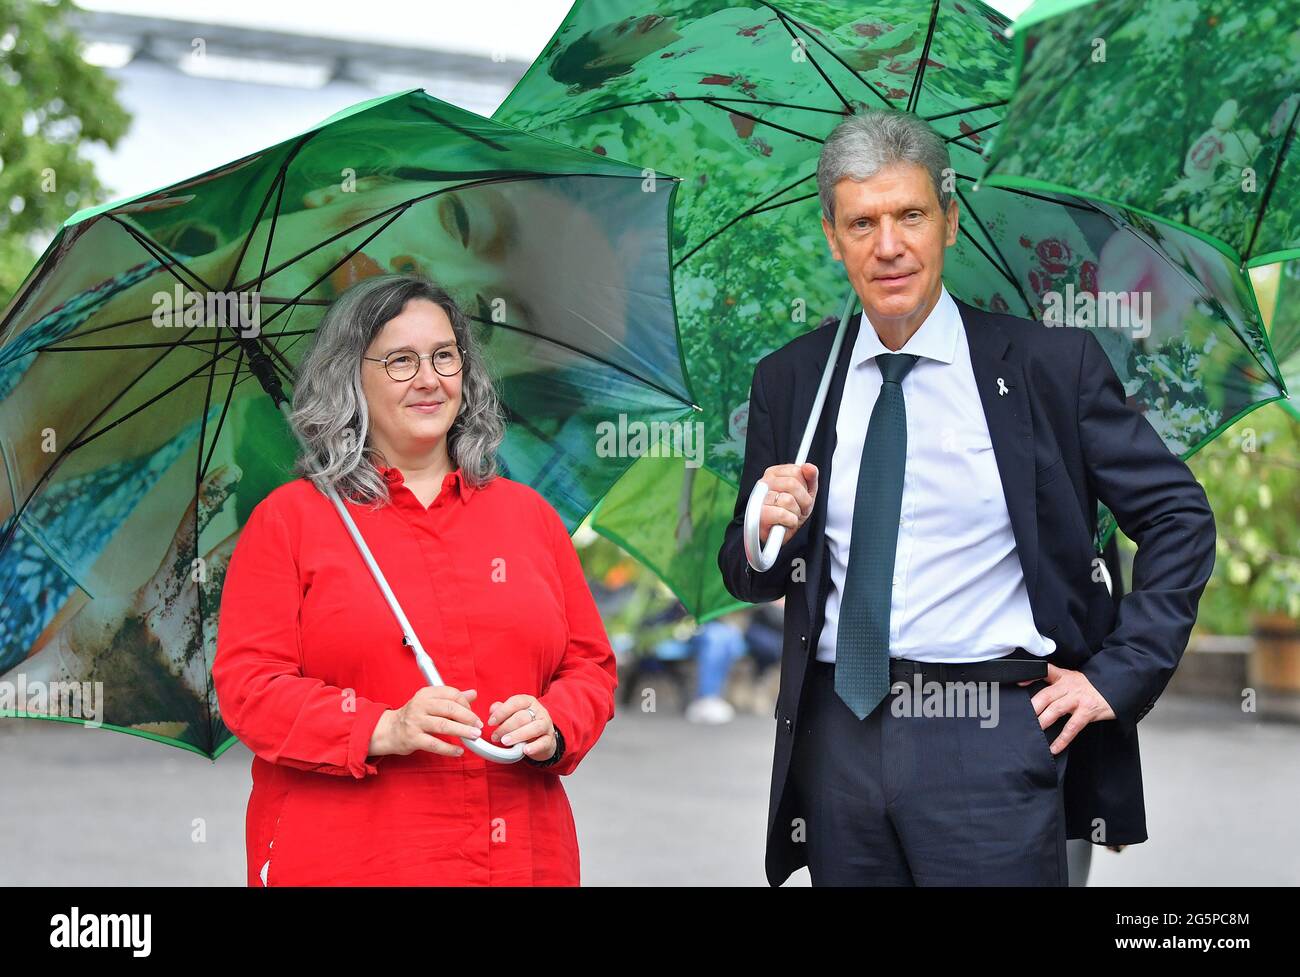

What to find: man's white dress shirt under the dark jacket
left=816, top=281, right=1056, bottom=661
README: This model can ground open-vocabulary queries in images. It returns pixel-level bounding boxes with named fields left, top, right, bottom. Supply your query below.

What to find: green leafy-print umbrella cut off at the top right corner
left=985, top=0, right=1300, bottom=266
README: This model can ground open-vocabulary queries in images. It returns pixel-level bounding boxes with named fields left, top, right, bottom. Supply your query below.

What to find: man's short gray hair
left=816, top=109, right=953, bottom=223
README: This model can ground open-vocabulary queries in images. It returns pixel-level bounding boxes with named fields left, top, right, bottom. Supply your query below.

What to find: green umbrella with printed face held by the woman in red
left=0, top=91, right=696, bottom=756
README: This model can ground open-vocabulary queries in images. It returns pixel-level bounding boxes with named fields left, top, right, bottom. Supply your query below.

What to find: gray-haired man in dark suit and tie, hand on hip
left=718, top=110, right=1214, bottom=885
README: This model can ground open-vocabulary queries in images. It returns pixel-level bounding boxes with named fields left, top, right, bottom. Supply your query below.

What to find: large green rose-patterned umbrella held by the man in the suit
left=495, top=0, right=1281, bottom=618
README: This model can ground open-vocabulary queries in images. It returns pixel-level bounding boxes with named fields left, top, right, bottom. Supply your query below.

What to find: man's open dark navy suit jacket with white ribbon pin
left=718, top=300, right=1214, bottom=885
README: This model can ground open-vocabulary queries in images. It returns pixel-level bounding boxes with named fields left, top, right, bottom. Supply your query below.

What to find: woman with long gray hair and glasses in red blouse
left=212, top=275, right=616, bottom=886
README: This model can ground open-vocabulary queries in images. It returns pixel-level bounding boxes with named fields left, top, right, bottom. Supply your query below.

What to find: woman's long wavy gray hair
left=290, top=274, right=506, bottom=508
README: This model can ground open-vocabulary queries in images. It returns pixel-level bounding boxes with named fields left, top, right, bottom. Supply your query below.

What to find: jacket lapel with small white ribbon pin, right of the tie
left=957, top=301, right=1039, bottom=607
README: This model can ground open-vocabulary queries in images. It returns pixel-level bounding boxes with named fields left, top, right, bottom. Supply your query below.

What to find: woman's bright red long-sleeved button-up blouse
left=212, top=468, right=618, bottom=886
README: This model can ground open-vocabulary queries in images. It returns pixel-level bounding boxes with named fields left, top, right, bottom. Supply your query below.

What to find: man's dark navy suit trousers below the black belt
left=790, top=651, right=1070, bottom=886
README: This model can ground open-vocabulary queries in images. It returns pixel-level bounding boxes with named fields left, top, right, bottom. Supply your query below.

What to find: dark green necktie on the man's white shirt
left=835, top=353, right=917, bottom=720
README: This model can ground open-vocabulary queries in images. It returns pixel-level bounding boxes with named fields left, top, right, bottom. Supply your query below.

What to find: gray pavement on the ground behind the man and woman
left=0, top=694, right=1300, bottom=885
